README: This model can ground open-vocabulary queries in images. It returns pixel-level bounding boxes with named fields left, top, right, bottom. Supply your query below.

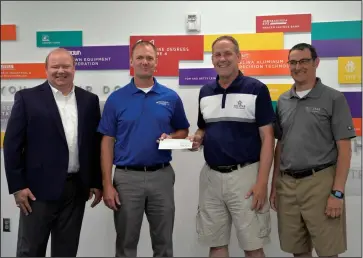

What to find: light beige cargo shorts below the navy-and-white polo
left=196, top=163, right=271, bottom=251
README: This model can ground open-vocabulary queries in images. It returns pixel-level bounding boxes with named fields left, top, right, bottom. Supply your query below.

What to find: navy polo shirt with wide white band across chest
left=198, top=73, right=275, bottom=166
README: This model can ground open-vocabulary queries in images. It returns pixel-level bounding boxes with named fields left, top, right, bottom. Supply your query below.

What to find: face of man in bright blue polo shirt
left=130, top=44, right=157, bottom=79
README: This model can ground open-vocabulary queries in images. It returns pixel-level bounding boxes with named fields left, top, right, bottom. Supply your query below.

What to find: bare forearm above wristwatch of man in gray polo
left=333, top=144, right=351, bottom=192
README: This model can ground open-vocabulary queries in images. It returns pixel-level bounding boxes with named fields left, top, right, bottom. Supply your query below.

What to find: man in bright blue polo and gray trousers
left=99, top=41, right=189, bottom=257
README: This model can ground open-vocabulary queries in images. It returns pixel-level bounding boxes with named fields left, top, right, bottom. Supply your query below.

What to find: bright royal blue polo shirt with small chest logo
left=98, top=78, right=189, bottom=166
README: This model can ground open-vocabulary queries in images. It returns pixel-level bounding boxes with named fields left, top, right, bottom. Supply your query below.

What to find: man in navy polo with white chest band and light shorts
left=189, top=36, right=275, bottom=257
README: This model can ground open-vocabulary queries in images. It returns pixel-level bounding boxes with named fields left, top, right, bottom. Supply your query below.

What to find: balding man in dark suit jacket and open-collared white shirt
left=4, top=49, right=102, bottom=257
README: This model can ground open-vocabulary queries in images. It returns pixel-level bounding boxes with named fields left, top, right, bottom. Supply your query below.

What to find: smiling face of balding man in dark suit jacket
left=46, top=50, right=75, bottom=89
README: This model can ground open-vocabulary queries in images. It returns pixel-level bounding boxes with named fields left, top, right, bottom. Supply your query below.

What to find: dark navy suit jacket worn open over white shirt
left=3, top=81, right=102, bottom=201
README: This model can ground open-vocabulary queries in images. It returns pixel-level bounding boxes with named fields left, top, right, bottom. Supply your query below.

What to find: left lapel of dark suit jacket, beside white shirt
left=40, top=81, right=67, bottom=143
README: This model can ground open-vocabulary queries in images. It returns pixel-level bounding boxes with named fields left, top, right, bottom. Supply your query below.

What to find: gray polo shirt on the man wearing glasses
left=274, top=78, right=356, bottom=171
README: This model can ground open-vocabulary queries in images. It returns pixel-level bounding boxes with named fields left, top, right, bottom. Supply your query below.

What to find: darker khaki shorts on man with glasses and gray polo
left=276, top=166, right=347, bottom=256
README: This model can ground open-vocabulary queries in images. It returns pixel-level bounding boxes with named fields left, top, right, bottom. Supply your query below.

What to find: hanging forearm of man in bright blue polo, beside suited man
left=101, top=136, right=114, bottom=187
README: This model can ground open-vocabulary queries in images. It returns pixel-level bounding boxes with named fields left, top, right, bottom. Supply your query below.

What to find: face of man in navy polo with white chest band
left=212, top=39, right=241, bottom=78
